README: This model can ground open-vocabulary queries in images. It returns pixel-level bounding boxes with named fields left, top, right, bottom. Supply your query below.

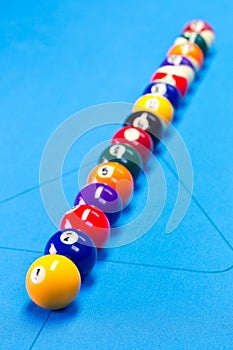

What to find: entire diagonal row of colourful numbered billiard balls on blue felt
left=26, top=20, right=214, bottom=310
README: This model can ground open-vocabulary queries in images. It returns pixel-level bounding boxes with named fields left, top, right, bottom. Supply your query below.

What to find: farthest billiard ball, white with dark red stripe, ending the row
left=183, top=19, right=215, bottom=48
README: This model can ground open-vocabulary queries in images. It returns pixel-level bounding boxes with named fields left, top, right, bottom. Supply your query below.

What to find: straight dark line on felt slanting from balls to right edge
left=162, top=159, right=233, bottom=251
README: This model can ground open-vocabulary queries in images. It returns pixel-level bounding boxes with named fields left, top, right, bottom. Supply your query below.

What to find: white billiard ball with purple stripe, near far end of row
left=157, top=55, right=196, bottom=85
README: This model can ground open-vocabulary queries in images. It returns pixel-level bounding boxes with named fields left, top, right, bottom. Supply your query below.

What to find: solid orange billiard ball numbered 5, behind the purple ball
left=87, top=162, right=134, bottom=207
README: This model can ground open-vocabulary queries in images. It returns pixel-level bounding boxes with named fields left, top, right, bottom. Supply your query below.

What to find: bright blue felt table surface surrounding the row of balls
left=0, top=0, right=233, bottom=350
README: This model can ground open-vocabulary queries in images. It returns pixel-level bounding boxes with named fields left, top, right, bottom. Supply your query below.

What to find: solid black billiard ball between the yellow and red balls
left=124, top=110, right=164, bottom=149
